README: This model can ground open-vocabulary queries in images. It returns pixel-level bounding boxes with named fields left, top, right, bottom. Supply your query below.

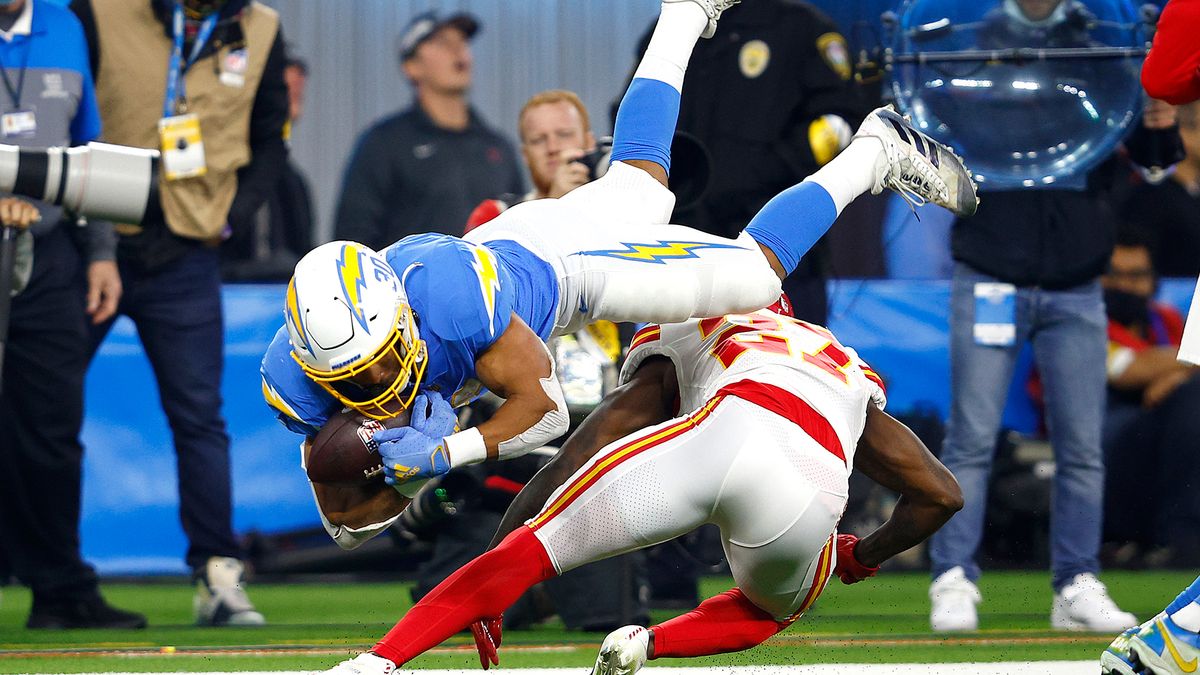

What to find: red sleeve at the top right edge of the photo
left=1141, top=0, right=1200, bottom=106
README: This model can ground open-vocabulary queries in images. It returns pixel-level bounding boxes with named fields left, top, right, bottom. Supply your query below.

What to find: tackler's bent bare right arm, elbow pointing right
left=853, top=405, right=962, bottom=567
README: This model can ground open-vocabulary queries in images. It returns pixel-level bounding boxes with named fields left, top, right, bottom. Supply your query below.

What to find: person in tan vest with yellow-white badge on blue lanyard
left=72, top=0, right=288, bottom=625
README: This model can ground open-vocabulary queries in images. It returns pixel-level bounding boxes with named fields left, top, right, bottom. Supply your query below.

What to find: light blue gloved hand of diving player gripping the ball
left=374, top=392, right=458, bottom=485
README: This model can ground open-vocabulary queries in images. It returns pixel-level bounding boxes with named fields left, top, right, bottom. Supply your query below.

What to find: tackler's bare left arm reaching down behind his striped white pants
left=487, top=357, right=679, bottom=550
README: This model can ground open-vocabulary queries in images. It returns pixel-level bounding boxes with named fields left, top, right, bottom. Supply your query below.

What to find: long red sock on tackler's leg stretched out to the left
left=371, top=527, right=556, bottom=665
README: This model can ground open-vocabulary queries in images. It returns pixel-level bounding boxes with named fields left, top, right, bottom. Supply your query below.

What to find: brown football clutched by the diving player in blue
left=307, top=408, right=409, bottom=485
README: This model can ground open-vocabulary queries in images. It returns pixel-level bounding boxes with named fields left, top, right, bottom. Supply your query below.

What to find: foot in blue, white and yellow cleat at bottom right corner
left=1100, top=577, right=1200, bottom=675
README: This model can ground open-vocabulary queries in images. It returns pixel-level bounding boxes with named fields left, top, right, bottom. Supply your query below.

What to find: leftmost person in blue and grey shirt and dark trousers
left=0, top=0, right=138, bottom=628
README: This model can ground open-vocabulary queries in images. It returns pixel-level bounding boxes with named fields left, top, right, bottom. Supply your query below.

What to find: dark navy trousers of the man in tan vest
left=92, top=247, right=241, bottom=569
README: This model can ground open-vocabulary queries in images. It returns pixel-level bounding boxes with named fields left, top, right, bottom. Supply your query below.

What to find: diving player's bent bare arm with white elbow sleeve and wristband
left=470, top=315, right=570, bottom=458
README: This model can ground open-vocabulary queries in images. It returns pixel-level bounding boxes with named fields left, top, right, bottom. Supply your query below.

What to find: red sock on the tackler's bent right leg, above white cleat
left=650, top=589, right=791, bottom=658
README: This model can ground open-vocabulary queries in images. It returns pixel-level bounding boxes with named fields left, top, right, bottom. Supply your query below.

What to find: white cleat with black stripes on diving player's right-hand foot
left=854, top=106, right=979, bottom=216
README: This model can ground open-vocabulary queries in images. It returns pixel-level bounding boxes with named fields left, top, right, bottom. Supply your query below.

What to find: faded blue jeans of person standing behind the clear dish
left=930, top=263, right=1106, bottom=589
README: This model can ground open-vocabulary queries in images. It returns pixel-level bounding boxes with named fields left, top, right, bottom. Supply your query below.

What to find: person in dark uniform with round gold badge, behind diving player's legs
left=642, top=0, right=866, bottom=324
